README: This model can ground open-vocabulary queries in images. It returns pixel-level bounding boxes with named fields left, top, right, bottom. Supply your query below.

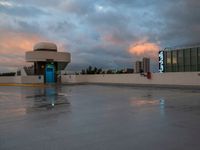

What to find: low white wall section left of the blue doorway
left=0, top=76, right=44, bottom=84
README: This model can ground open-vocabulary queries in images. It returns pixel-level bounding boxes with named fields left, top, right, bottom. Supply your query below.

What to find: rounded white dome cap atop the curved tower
left=33, top=42, right=57, bottom=52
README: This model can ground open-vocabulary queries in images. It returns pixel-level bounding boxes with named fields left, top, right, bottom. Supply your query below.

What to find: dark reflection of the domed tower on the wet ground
left=27, top=86, right=70, bottom=109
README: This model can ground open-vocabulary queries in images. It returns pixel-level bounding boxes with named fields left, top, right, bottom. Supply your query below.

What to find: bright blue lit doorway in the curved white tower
left=45, top=64, right=55, bottom=83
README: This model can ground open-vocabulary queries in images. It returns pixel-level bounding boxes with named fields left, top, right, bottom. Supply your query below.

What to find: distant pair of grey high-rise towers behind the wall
left=135, top=57, right=150, bottom=73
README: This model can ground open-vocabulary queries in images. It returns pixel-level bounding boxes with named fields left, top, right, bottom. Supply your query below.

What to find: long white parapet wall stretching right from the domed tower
left=62, top=72, right=200, bottom=86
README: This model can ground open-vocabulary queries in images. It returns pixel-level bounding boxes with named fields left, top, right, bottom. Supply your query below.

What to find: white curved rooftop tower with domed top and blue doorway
left=25, top=42, right=71, bottom=83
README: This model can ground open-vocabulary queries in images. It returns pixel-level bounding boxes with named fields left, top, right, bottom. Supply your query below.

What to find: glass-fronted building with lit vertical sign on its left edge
left=159, top=46, right=200, bottom=72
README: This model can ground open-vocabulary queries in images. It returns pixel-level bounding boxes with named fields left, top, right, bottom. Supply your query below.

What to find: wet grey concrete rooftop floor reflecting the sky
left=0, top=85, right=200, bottom=150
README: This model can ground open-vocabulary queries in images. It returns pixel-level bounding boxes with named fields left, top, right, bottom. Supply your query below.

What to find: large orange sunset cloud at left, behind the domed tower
left=0, top=31, right=46, bottom=69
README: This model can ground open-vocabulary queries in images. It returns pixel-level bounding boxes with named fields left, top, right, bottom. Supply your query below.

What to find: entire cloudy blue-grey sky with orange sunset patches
left=0, top=0, right=200, bottom=72
